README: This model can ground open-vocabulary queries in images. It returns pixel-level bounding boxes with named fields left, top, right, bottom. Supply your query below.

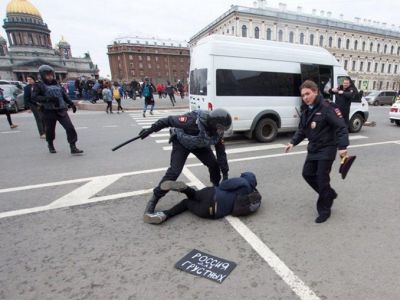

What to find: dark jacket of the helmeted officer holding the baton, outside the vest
left=150, top=111, right=229, bottom=174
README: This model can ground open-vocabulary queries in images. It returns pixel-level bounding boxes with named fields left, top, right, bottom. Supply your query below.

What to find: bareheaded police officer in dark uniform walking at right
left=285, top=80, right=349, bottom=223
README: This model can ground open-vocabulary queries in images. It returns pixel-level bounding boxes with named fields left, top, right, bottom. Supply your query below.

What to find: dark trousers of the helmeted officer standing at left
left=43, top=110, right=78, bottom=144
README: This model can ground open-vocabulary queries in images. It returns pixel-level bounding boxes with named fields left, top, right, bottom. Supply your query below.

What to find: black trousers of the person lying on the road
left=164, top=187, right=215, bottom=219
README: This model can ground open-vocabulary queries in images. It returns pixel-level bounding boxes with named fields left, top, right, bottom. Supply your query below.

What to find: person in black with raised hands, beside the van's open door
left=329, top=78, right=358, bottom=127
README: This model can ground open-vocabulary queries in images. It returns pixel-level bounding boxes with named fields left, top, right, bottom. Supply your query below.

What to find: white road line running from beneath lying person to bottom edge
left=182, top=168, right=320, bottom=300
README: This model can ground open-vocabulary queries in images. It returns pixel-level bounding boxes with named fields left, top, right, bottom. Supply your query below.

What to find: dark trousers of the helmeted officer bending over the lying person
left=154, top=139, right=221, bottom=198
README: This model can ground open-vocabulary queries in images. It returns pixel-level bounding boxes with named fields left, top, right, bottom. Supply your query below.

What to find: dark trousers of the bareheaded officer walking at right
left=303, top=160, right=335, bottom=216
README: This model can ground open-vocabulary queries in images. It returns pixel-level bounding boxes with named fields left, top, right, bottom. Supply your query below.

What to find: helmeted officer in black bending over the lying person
left=139, top=109, right=232, bottom=222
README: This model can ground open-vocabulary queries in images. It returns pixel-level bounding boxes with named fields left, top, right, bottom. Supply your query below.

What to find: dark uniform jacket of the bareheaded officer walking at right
left=291, top=96, right=349, bottom=160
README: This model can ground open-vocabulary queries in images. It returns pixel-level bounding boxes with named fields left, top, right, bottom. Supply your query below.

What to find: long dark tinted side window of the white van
left=217, top=69, right=301, bottom=97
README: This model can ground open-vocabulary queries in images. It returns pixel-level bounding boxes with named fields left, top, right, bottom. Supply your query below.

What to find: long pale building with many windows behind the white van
left=189, top=0, right=400, bottom=90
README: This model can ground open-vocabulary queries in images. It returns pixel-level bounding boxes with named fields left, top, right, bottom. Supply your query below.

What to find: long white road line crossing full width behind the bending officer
left=0, top=140, right=400, bottom=198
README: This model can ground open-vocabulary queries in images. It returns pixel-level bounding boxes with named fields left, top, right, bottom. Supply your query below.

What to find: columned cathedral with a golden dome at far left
left=0, top=0, right=98, bottom=81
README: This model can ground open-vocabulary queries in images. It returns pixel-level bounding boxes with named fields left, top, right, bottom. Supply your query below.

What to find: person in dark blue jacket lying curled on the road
left=145, top=172, right=261, bottom=224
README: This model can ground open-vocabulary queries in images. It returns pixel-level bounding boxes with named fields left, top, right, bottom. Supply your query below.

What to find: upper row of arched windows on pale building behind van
left=239, top=25, right=400, bottom=55
